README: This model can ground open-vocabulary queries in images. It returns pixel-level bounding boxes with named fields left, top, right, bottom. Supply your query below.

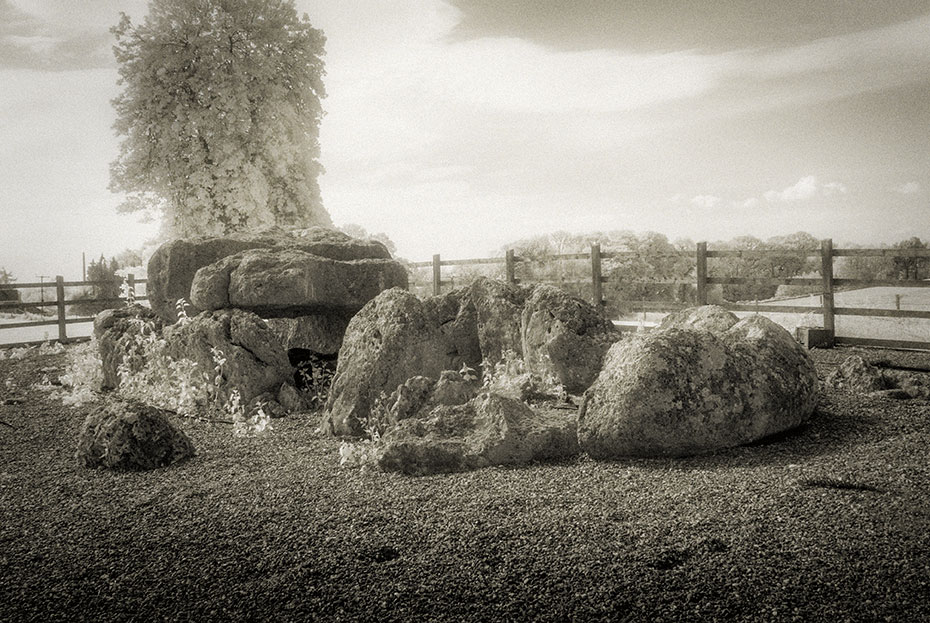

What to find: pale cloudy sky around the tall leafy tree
left=0, top=0, right=930, bottom=282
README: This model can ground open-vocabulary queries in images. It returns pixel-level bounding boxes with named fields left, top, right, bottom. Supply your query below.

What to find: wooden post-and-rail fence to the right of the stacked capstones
left=412, top=239, right=930, bottom=349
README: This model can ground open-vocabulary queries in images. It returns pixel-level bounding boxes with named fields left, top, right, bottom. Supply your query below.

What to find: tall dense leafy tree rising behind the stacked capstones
left=110, top=0, right=331, bottom=236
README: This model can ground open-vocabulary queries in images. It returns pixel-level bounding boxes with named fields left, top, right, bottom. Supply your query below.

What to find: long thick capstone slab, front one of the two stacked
left=190, top=248, right=407, bottom=318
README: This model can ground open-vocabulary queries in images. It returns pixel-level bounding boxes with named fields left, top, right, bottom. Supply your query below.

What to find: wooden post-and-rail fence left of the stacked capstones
left=0, top=274, right=147, bottom=348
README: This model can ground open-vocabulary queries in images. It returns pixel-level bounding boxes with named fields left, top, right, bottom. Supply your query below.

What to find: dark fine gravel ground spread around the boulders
left=0, top=351, right=930, bottom=622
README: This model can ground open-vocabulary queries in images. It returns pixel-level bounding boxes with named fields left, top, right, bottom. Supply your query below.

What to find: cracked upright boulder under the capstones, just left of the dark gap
left=163, top=309, right=294, bottom=404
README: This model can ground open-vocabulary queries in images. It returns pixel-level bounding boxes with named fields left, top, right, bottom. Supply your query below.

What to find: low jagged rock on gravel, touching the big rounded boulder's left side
left=377, top=394, right=578, bottom=475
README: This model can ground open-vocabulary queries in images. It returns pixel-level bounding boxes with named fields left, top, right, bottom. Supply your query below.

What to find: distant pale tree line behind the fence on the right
left=500, top=231, right=930, bottom=315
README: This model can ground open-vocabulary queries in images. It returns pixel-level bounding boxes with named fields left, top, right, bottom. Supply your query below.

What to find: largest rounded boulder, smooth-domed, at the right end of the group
left=578, top=312, right=817, bottom=458
